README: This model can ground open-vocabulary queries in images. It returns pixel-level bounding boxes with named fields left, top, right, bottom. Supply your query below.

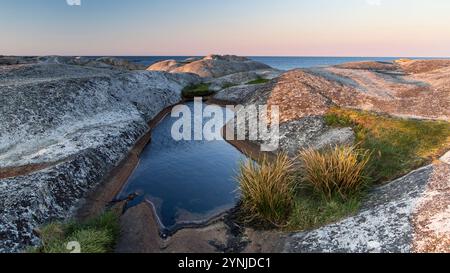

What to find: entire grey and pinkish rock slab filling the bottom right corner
left=284, top=151, right=450, bottom=253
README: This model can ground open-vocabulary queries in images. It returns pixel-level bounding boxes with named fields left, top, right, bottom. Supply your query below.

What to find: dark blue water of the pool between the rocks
left=120, top=103, right=245, bottom=229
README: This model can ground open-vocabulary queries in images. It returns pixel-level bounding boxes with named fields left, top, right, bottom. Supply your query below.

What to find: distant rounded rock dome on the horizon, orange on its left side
left=147, top=55, right=271, bottom=78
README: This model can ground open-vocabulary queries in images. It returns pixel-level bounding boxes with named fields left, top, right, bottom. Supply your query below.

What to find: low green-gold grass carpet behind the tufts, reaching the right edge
left=325, top=108, right=450, bottom=183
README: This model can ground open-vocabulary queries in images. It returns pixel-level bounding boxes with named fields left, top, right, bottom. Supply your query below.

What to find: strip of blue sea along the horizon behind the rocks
left=120, top=56, right=442, bottom=70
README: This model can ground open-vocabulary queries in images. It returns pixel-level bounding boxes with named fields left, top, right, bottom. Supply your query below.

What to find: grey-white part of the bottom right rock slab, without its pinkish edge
left=285, top=166, right=433, bottom=253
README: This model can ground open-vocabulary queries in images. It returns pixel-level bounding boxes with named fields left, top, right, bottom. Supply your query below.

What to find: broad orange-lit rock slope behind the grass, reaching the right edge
left=215, top=60, right=450, bottom=122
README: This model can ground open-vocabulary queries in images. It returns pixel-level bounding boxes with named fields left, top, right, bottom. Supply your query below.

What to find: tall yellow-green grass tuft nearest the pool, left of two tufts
left=237, top=154, right=297, bottom=226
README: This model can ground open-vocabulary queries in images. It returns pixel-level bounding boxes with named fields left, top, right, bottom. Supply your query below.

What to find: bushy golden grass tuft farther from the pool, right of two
left=299, top=146, right=370, bottom=200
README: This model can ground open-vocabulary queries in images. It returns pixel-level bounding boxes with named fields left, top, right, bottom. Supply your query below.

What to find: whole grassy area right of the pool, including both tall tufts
left=239, top=108, right=450, bottom=231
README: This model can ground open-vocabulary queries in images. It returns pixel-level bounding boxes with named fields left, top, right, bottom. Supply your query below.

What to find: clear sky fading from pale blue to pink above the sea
left=0, top=0, right=450, bottom=57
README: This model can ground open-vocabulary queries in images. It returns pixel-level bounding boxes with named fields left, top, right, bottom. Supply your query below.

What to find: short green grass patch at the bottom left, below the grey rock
left=29, top=212, right=120, bottom=253
